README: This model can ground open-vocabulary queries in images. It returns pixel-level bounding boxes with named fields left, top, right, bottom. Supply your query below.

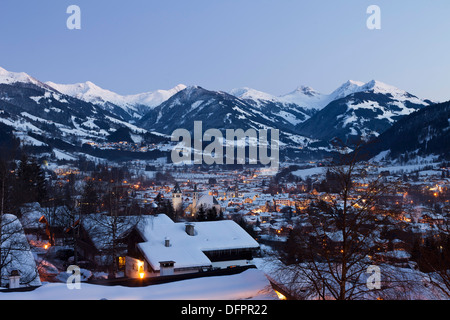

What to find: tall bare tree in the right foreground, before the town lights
left=280, top=142, right=400, bottom=300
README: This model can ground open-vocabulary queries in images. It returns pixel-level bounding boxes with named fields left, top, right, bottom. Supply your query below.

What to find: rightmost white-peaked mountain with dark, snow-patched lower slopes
left=297, top=80, right=432, bottom=141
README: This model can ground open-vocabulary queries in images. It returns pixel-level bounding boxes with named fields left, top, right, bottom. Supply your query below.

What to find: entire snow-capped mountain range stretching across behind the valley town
left=0, top=68, right=446, bottom=164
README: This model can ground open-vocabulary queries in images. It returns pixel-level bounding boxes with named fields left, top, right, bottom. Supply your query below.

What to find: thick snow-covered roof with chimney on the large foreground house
left=138, top=214, right=259, bottom=270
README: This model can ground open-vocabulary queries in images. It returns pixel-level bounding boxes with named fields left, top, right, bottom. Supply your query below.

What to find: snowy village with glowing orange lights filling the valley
left=2, top=156, right=450, bottom=298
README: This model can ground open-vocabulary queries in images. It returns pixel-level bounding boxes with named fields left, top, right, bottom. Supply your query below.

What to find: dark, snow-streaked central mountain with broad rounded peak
left=137, top=86, right=311, bottom=149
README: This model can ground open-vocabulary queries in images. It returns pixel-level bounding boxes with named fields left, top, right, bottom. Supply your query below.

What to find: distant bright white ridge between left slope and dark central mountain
left=46, top=81, right=186, bottom=120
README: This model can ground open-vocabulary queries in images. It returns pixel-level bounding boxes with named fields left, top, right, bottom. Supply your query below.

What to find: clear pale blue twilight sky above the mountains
left=0, top=0, right=450, bottom=101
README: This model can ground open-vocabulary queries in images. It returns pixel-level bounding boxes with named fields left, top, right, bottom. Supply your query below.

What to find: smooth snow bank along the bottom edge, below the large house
left=0, top=269, right=277, bottom=300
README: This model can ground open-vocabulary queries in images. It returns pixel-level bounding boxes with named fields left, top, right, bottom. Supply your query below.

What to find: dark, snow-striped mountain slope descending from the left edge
left=0, top=69, right=168, bottom=158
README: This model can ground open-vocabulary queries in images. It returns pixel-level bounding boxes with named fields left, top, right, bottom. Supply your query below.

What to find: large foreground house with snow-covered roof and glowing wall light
left=125, top=214, right=259, bottom=278
